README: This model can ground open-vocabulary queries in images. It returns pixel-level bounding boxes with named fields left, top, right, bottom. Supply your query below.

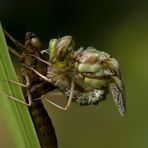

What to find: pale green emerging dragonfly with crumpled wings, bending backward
left=24, top=36, right=126, bottom=116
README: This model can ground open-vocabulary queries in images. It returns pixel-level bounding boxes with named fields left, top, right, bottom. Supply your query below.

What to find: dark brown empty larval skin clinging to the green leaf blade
left=4, top=30, right=58, bottom=148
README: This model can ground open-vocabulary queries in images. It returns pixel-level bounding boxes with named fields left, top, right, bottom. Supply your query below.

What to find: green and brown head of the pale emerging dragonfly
left=49, top=36, right=74, bottom=68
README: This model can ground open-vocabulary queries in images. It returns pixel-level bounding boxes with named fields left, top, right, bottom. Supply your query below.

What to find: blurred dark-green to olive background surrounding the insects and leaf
left=0, top=0, right=148, bottom=148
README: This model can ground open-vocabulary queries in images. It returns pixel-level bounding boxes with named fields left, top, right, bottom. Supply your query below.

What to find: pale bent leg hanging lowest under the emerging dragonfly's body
left=42, top=79, right=74, bottom=111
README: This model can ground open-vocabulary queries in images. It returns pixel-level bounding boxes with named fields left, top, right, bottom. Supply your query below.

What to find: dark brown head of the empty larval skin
left=25, top=32, right=42, bottom=53
